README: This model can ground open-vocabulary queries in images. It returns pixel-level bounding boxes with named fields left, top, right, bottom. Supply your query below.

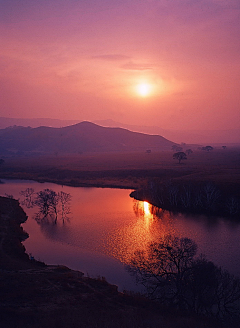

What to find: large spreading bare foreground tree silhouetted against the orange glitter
left=130, top=235, right=197, bottom=307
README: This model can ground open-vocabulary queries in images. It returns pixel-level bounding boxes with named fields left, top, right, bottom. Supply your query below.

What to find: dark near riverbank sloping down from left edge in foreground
left=0, top=197, right=227, bottom=328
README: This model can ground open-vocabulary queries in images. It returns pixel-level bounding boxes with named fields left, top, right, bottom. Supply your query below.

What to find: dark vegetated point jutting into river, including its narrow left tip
left=131, top=180, right=240, bottom=219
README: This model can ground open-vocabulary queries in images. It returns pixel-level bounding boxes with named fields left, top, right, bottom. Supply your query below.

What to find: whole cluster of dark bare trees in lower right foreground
left=128, top=235, right=240, bottom=318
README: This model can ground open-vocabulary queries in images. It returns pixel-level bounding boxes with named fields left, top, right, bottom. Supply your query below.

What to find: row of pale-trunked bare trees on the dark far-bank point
left=144, top=181, right=240, bottom=215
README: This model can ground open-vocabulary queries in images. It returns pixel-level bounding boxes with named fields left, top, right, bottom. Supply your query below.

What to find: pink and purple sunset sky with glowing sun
left=0, top=0, right=240, bottom=130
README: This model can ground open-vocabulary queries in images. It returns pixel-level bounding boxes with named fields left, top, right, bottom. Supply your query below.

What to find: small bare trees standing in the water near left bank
left=20, top=188, right=71, bottom=223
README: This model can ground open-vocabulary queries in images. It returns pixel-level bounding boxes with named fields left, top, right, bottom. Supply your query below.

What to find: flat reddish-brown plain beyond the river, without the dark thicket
left=0, top=148, right=240, bottom=189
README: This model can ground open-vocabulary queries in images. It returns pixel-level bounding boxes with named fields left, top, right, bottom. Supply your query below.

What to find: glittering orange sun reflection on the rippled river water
left=106, top=200, right=174, bottom=264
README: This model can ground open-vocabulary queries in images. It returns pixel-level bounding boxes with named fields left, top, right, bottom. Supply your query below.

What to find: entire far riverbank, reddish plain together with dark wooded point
left=0, top=148, right=240, bottom=218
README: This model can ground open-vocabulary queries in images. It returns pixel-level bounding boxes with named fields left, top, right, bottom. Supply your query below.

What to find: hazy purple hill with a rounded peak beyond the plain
left=0, top=121, right=174, bottom=155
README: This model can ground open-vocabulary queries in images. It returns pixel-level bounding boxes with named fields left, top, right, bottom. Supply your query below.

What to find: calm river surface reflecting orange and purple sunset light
left=0, top=180, right=240, bottom=290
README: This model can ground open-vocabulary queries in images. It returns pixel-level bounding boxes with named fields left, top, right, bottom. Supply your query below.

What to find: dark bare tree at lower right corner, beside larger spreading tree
left=188, top=257, right=240, bottom=318
